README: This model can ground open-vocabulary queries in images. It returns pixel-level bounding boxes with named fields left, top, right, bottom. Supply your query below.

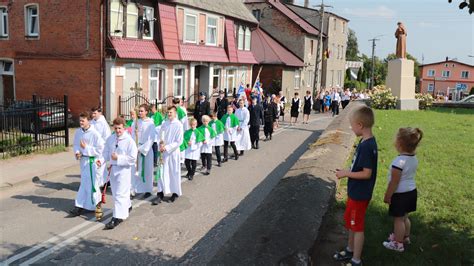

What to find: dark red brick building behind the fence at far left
left=0, top=0, right=103, bottom=115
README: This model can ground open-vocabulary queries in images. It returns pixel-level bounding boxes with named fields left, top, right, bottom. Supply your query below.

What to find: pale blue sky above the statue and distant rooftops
left=296, top=0, right=474, bottom=65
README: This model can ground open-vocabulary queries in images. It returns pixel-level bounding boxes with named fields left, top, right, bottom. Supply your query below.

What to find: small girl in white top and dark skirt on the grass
left=383, top=127, right=423, bottom=252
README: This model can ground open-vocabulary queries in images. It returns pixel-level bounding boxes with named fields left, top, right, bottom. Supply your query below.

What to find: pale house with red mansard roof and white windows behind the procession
left=106, top=0, right=258, bottom=119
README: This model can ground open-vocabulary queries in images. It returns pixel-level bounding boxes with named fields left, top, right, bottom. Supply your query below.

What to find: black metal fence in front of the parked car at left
left=0, top=95, right=72, bottom=158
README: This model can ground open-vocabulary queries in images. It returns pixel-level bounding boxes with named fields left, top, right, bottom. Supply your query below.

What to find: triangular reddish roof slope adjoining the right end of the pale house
left=252, top=28, right=304, bottom=67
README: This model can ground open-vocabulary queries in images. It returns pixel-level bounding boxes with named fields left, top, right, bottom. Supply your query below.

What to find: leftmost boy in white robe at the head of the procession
left=70, top=113, right=104, bottom=216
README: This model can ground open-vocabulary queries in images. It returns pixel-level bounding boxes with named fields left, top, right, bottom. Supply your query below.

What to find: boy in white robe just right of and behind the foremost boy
left=132, top=104, right=155, bottom=197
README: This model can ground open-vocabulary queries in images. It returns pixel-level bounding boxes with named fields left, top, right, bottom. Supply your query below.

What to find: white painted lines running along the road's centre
left=1, top=117, right=331, bottom=265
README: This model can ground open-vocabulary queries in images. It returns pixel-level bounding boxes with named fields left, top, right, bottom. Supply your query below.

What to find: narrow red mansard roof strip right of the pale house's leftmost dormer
left=158, top=3, right=181, bottom=60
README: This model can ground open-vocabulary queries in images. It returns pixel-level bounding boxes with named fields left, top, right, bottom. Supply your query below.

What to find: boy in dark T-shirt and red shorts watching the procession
left=334, top=106, right=378, bottom=265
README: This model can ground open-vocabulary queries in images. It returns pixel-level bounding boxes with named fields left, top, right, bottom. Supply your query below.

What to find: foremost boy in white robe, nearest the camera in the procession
left=104, top=118, right=138, bottom=229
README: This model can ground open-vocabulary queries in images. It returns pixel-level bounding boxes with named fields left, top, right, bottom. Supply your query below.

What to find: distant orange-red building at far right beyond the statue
left=420, top=60, right=474, bottom=99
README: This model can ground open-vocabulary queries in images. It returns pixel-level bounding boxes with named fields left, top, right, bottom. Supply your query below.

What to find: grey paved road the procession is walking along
left=0, top=114, right=332, bottom=265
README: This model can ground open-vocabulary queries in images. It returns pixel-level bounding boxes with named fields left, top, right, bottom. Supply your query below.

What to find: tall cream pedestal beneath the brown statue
left=386, top=58, right=418, bottom=110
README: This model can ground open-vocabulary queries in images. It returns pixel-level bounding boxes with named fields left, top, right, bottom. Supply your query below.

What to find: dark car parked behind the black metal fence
left=0, top=101, right=73, bottom=132
